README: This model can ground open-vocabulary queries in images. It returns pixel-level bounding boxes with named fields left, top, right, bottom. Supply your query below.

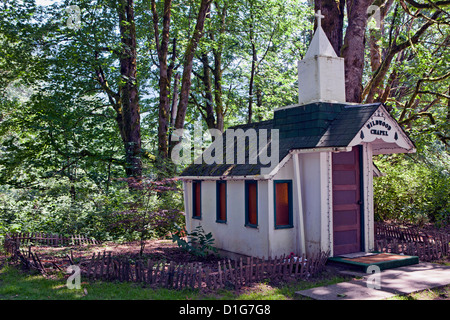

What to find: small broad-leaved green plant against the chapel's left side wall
left=172, top=226, right=217, bottom=258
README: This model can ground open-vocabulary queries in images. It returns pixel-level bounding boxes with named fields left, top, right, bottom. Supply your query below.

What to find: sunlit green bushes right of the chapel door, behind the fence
left=374, top=146, right=450, bottom=227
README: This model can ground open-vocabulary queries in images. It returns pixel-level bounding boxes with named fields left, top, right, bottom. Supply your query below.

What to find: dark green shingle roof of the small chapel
left=180, top=103, right=381, bottom=177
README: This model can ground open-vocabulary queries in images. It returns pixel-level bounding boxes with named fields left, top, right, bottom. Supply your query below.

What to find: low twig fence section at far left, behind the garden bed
left=5, top=232, right=100, bottom=247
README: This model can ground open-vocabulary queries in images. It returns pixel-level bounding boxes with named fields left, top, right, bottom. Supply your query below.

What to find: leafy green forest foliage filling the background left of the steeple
left=0, top=0, right=311, bottom=240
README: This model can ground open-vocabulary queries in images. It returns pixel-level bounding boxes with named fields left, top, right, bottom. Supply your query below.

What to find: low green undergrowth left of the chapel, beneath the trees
left=0, top=175, right=184, bottom=241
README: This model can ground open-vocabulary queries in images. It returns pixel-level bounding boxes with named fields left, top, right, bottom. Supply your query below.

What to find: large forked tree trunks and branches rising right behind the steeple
left=314, top=0, right=446, bottom=102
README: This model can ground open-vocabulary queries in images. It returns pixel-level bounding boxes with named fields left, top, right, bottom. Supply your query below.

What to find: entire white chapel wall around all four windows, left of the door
left=185, top=152, right=332, bottom=257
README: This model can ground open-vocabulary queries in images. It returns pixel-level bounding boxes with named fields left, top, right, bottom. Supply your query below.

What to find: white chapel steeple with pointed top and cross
left=298, top=10, right=346, bottom=104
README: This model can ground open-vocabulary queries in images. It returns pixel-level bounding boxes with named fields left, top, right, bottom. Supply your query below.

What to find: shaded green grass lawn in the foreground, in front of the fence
left=0, top=264, right=346, bottom=300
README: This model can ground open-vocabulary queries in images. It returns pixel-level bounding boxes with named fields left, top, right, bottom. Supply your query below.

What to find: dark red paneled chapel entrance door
left=333, top=146, right=361, bottom=256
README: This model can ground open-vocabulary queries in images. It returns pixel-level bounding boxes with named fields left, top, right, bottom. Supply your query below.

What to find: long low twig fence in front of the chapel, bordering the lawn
left=82, top=252, right=329, bottom=290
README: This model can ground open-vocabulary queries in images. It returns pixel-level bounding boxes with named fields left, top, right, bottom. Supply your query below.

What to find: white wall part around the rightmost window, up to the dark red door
left=269, top=152, right=333, bottom=256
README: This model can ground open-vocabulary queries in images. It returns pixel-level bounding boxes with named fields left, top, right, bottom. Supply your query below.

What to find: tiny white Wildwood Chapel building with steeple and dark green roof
left=179, top=11, right=415, bottom=258
